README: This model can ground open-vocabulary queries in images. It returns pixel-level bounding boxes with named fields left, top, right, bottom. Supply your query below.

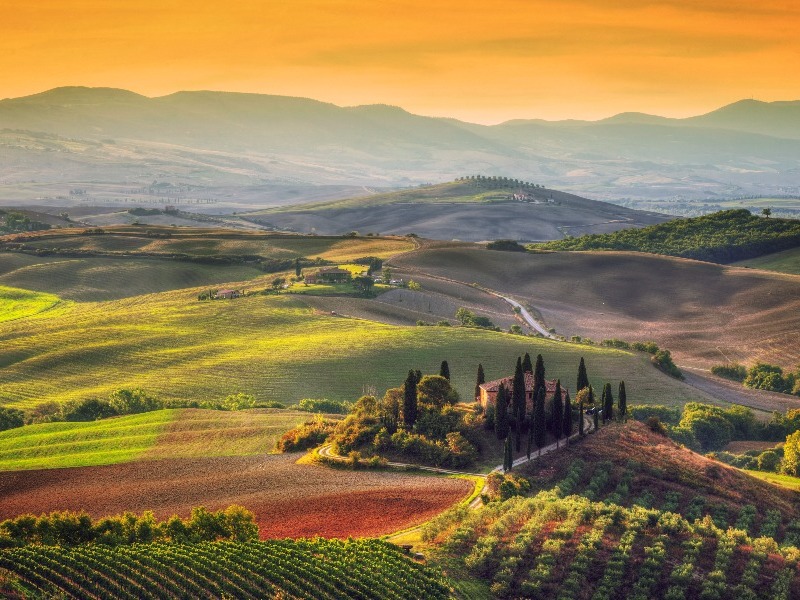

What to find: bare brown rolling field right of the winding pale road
left=392, top=246, right=800, bottom=369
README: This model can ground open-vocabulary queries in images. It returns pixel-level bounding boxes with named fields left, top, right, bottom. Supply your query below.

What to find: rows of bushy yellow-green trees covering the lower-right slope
left=423, top=488, right=800, bottom=600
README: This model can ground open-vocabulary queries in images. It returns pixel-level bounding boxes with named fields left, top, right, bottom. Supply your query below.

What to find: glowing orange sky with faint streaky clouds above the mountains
left=0, top=0, right=800, bottom=122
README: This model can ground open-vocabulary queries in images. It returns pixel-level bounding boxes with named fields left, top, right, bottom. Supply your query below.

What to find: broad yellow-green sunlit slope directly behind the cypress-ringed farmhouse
left=0, top=290, right=702, bottom=407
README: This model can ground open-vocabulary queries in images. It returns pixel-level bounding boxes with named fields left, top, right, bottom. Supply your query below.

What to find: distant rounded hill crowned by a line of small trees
left=243, top=177, right=669, bottom=241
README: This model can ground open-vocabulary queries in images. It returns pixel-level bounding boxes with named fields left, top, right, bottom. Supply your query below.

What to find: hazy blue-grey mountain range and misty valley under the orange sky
left=0, top=87, right=800, bottom=208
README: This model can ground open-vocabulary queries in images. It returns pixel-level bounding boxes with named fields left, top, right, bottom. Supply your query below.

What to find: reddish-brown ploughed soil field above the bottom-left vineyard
left=0, top=454, right=472, bottom=538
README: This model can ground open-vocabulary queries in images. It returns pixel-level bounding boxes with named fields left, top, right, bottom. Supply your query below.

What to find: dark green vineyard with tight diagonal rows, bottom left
left=0, top=539, right=450, bottom=600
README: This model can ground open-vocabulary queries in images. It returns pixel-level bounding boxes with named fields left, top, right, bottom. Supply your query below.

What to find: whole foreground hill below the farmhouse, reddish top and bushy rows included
left=423, top=423, right=800, bottom=600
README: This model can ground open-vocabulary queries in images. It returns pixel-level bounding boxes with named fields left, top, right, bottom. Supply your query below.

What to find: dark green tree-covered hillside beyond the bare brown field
left=535, top=210, right=800, bottom=263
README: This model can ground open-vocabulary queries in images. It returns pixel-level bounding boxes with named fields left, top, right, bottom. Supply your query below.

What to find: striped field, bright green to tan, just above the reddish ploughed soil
left=0, top=409, right=310, bottom=471
